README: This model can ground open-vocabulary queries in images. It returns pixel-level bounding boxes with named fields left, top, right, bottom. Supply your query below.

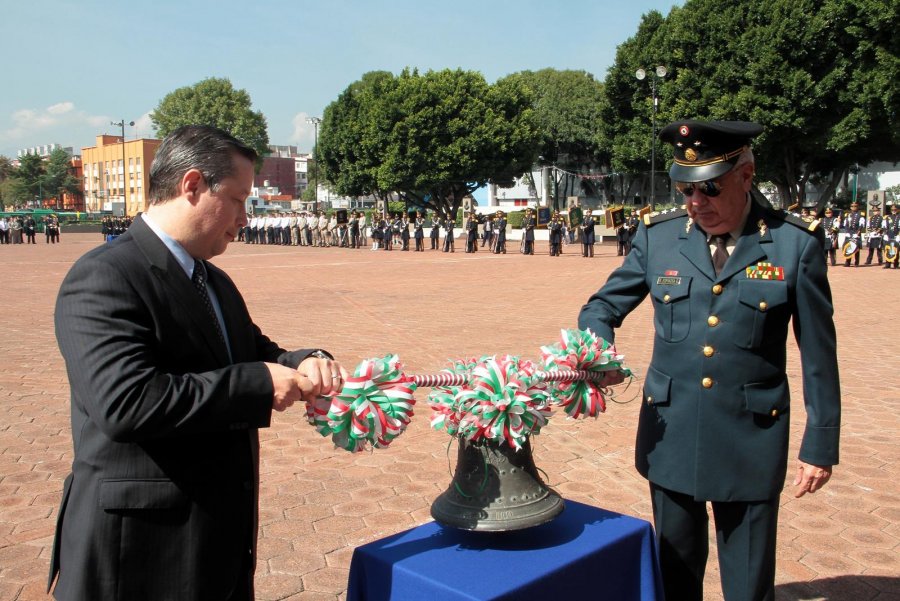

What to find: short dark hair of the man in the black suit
left=147, top=125, right=258, bottom=205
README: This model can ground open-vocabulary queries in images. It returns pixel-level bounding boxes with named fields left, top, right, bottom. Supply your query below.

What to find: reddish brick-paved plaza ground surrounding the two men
left=0, top=231, right=900, bottom=601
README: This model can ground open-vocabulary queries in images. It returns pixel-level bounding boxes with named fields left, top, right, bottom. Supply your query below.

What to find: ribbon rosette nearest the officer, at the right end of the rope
left=541, top=329, right=631, bottom=418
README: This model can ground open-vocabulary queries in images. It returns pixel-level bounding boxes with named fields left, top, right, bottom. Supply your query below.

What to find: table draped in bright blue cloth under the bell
left=347, top=501, right=663, bottom=601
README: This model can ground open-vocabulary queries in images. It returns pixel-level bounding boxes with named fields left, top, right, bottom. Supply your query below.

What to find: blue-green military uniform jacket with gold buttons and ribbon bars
left=578, top=203, right=840, bottom=501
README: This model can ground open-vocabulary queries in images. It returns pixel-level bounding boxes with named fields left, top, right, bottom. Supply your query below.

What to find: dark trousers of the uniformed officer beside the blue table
left=650, top=482, right=778, bottom=601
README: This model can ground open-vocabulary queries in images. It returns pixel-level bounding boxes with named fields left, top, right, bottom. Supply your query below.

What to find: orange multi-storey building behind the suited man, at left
left=81, top=134, right=160, bottom=216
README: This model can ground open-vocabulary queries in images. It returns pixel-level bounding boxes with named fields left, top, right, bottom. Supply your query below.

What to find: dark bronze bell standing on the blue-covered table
left=431, top=438, right=564, bottom=532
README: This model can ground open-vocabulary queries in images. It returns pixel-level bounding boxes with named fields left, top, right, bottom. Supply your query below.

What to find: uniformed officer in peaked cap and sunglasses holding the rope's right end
left=578, top=121, right=840, bottom=601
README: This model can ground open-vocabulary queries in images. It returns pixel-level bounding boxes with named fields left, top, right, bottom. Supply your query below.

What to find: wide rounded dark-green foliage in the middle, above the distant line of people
left=317, top=69, right=538, bottom=215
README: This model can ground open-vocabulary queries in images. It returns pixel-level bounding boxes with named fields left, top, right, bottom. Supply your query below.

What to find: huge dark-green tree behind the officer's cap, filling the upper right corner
left=605, top=0, right=900, bottom=205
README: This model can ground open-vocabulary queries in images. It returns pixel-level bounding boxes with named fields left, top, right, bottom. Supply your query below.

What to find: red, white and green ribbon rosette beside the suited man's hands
left=307, top=355, right=416, bottom=452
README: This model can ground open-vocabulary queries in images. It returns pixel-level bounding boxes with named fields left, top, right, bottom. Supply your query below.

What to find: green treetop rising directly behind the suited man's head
left=150, top=77, right=269, bottom=157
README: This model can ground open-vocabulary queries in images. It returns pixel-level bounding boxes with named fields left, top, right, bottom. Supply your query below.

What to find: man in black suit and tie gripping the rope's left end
left=50, top=126, right=346, bottom=601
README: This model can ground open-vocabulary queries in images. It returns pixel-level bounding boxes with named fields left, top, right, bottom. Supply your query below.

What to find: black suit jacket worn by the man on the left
left=50, top=219, right=310, bottom=601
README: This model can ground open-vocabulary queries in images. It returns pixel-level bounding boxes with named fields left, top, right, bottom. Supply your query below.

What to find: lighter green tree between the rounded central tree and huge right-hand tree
left=505, top=69, right=608, bottom=208
